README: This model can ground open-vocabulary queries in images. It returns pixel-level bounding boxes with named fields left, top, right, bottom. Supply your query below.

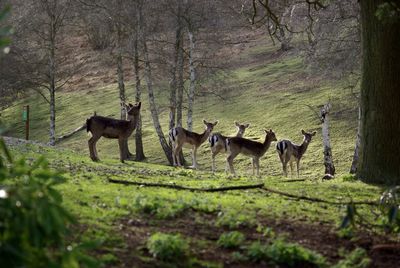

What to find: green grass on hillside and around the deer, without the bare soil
left=1, top=38, right=383, bottom=262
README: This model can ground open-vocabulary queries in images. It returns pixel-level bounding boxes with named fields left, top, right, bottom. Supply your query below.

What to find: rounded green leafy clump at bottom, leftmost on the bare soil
left=147, top=232, right=189, bottom=263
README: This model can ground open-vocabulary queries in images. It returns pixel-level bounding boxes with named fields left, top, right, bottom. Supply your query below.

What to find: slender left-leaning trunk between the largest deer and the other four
left=138, top=0, right=172, bottom=165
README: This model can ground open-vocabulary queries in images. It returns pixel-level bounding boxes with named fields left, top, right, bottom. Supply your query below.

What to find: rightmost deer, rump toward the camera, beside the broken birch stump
left=276, top=129, right=317, bottom=177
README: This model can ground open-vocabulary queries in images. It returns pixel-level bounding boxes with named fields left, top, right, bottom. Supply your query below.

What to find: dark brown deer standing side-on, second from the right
left=226, top=129, right=276, bottom=177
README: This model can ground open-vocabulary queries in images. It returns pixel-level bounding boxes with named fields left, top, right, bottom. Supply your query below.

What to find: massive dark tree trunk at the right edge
left=357, top=0, right=400, bottom=184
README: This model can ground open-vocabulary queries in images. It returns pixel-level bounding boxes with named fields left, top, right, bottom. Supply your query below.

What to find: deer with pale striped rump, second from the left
left=169, top=119, right=218, bottom=169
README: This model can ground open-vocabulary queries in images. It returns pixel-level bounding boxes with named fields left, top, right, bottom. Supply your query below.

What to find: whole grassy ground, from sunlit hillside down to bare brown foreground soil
left=0, top=28, right=400, bottom=267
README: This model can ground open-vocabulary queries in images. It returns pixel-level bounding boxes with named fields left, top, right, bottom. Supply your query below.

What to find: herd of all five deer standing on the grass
left=86, top=102, right=316, bottom=176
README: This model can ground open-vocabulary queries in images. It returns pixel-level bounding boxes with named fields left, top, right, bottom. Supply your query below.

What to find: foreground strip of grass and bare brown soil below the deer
left=6, top=138, right=400, bottom=267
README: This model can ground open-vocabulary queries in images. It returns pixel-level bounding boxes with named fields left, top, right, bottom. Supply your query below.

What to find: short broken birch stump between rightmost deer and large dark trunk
left=321, top=103, right=335, bottom=176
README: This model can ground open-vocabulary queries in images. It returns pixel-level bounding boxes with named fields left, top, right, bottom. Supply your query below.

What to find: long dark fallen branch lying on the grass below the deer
left=108, top=178, right=264, bottom=192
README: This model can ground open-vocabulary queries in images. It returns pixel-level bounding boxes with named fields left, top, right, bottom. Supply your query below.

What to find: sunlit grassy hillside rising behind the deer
left=1, top=36, right=357, bottom=178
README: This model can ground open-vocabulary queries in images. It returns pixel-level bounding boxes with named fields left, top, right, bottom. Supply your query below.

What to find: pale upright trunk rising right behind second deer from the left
left=187, top=29, right=196, bottom=131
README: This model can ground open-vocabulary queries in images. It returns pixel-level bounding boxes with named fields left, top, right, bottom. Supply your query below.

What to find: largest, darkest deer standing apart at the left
left=86, top=102, right=141, bottom=163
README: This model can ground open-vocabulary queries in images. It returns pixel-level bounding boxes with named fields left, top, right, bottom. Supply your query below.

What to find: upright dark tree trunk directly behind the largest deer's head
left=133, top=28, right=146, bottom=161
